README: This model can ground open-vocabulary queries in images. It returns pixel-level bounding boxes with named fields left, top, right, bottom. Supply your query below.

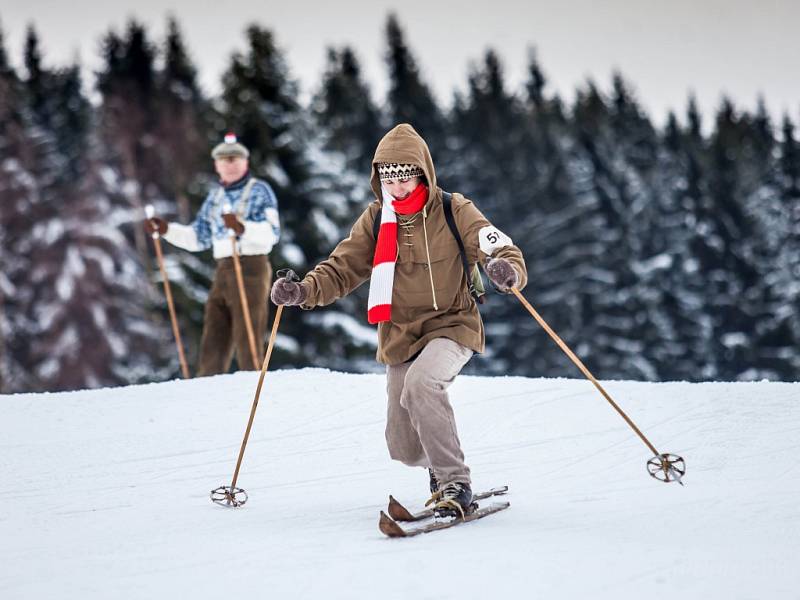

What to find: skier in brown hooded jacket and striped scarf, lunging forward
left=271, top=124, right=527, bottom=516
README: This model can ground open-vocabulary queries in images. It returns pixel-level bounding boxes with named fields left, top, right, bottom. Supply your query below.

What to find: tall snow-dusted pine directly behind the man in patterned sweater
left=219, top=25, right=376, bottom=368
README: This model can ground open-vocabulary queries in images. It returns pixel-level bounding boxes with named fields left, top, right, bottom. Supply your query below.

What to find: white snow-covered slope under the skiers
left=0, top=369, right=800, bottom=600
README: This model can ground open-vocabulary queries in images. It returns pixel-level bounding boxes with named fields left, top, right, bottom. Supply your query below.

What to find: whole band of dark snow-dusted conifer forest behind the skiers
left=0, top=15, right=800, bottom=393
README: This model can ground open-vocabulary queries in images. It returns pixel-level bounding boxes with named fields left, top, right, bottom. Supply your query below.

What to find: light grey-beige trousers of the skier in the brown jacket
left=386, top=338, right=472, bottom=485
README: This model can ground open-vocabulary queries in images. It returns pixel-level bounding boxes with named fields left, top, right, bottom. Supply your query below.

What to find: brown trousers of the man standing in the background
left=197, top=254, right=272, bottom=376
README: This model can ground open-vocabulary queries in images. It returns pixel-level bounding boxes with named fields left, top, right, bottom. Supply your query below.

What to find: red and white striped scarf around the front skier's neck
left=367, top=183, right=428, bottom=324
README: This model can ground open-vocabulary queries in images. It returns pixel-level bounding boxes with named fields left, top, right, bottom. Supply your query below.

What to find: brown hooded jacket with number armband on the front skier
left=302, top=123, right=527, bottom=365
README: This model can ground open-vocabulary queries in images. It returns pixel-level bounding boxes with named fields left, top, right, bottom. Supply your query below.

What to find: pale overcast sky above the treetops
left=0, top=0, right=800, bottom=123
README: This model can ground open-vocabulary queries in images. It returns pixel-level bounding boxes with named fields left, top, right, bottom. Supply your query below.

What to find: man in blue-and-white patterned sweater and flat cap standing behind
left=145, top=134, right=280, bottom=376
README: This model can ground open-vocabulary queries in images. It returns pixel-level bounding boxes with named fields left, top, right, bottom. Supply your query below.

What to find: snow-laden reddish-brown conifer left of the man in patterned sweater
left=21, top=143, right=177, bottom=391
